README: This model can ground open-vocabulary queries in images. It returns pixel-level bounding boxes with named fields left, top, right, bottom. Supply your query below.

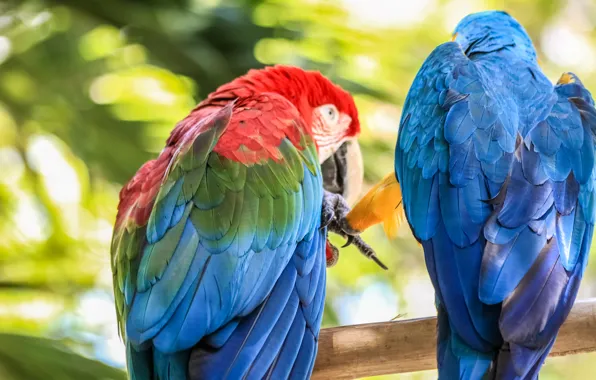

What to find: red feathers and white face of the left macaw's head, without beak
left=168, top=65, right=360, bottom=162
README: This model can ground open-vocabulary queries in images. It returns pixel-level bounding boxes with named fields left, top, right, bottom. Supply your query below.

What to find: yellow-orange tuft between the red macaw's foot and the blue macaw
left=346, top=171, right=405, bottom=238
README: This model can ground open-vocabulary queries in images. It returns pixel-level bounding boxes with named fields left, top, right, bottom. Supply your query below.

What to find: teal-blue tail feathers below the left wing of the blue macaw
left=437, top=305, right=495, bottom=380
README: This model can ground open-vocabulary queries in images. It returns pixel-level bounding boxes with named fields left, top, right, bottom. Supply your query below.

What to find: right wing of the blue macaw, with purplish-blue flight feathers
left=480, top=74, right=596, bottom=376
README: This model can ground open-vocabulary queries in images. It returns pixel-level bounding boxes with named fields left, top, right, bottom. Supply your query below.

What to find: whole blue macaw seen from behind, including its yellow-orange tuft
left=347, top=11, right=596, bottom=379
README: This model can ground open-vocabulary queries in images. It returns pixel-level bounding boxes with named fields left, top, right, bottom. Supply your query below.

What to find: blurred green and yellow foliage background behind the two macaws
left=0, top=0, right=596, bottom=380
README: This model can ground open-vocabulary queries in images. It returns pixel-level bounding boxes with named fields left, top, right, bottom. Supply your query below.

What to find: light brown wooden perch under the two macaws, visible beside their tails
left=313, top=298, right=596, bottom=379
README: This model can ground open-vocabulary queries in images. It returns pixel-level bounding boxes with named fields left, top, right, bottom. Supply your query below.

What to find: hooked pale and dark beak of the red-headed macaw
left=321, top=140, right=364, bottom=205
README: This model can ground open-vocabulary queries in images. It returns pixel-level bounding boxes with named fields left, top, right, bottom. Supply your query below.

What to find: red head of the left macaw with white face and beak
left=210, top=65, right=364, bottom=203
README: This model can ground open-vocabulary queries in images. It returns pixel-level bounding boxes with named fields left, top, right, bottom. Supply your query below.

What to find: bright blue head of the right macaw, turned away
left=454, top=11, right=536, bottom=62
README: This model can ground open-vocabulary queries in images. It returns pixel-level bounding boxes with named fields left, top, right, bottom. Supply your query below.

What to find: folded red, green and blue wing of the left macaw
left=112, top=94, right=325, bottom=378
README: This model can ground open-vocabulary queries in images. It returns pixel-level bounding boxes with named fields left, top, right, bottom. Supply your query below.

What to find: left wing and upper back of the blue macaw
left=395, top=43, right=518, bottom=351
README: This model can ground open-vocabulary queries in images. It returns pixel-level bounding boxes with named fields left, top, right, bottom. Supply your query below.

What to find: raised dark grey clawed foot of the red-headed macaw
left=321, top=191, right=388, bottom=270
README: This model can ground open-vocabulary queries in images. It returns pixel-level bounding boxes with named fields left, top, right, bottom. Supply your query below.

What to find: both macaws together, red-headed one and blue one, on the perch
left=112, top=12, right=596, bottom=380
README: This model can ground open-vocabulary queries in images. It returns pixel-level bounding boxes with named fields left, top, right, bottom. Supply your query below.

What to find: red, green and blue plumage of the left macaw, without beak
left=112, top=66, right=372, bottom=380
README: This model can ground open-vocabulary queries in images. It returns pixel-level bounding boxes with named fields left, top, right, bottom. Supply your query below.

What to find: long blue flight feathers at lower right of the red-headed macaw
left=190, top=232, right=326, bottom=379
